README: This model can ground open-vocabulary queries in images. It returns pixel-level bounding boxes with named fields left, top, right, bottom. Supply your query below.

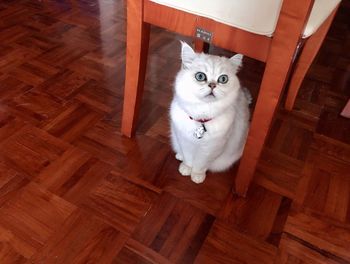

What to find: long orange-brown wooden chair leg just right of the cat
left=234, top=0, right=313, bottom=196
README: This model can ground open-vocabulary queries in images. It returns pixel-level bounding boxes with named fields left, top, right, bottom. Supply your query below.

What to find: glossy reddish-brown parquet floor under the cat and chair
left=0, top=0, right=350, bottom=264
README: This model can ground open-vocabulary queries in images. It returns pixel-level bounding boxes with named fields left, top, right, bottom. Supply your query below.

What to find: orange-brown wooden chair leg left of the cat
left=121, top=0, right=150, bottom=137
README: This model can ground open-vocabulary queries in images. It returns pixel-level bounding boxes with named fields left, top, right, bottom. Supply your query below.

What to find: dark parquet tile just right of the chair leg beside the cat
left=255, top=111, right=316, bottom=199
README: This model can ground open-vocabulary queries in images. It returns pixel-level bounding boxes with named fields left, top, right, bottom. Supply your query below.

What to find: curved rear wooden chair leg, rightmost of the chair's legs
left=285, top=10, right=337, bottom=111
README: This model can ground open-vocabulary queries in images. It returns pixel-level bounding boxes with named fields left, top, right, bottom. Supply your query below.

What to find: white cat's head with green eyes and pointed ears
left=175, top=42, right=243, bottom=102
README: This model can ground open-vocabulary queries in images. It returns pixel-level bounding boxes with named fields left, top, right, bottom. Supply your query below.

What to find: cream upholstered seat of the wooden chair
left=151, top=0, right=341, bottom=38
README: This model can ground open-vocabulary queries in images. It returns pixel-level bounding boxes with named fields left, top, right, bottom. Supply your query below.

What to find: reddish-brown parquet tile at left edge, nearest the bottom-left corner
left=0, top=183, right=75, bottom=258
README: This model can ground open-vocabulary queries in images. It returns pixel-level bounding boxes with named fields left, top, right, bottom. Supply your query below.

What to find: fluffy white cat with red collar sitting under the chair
left=170, top=42, right=250, bottom=183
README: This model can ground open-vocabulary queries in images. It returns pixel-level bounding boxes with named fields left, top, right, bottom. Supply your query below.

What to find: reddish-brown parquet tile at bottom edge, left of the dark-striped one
left=30, top=210, right=126, bottom=264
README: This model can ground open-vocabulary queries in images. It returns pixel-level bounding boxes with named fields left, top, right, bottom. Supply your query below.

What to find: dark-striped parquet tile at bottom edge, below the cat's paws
left=132, top=192, right=215, bottom=263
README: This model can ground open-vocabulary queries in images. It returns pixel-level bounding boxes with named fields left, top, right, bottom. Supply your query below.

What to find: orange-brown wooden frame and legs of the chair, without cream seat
left=122, top=0, right=339, bottom=196
